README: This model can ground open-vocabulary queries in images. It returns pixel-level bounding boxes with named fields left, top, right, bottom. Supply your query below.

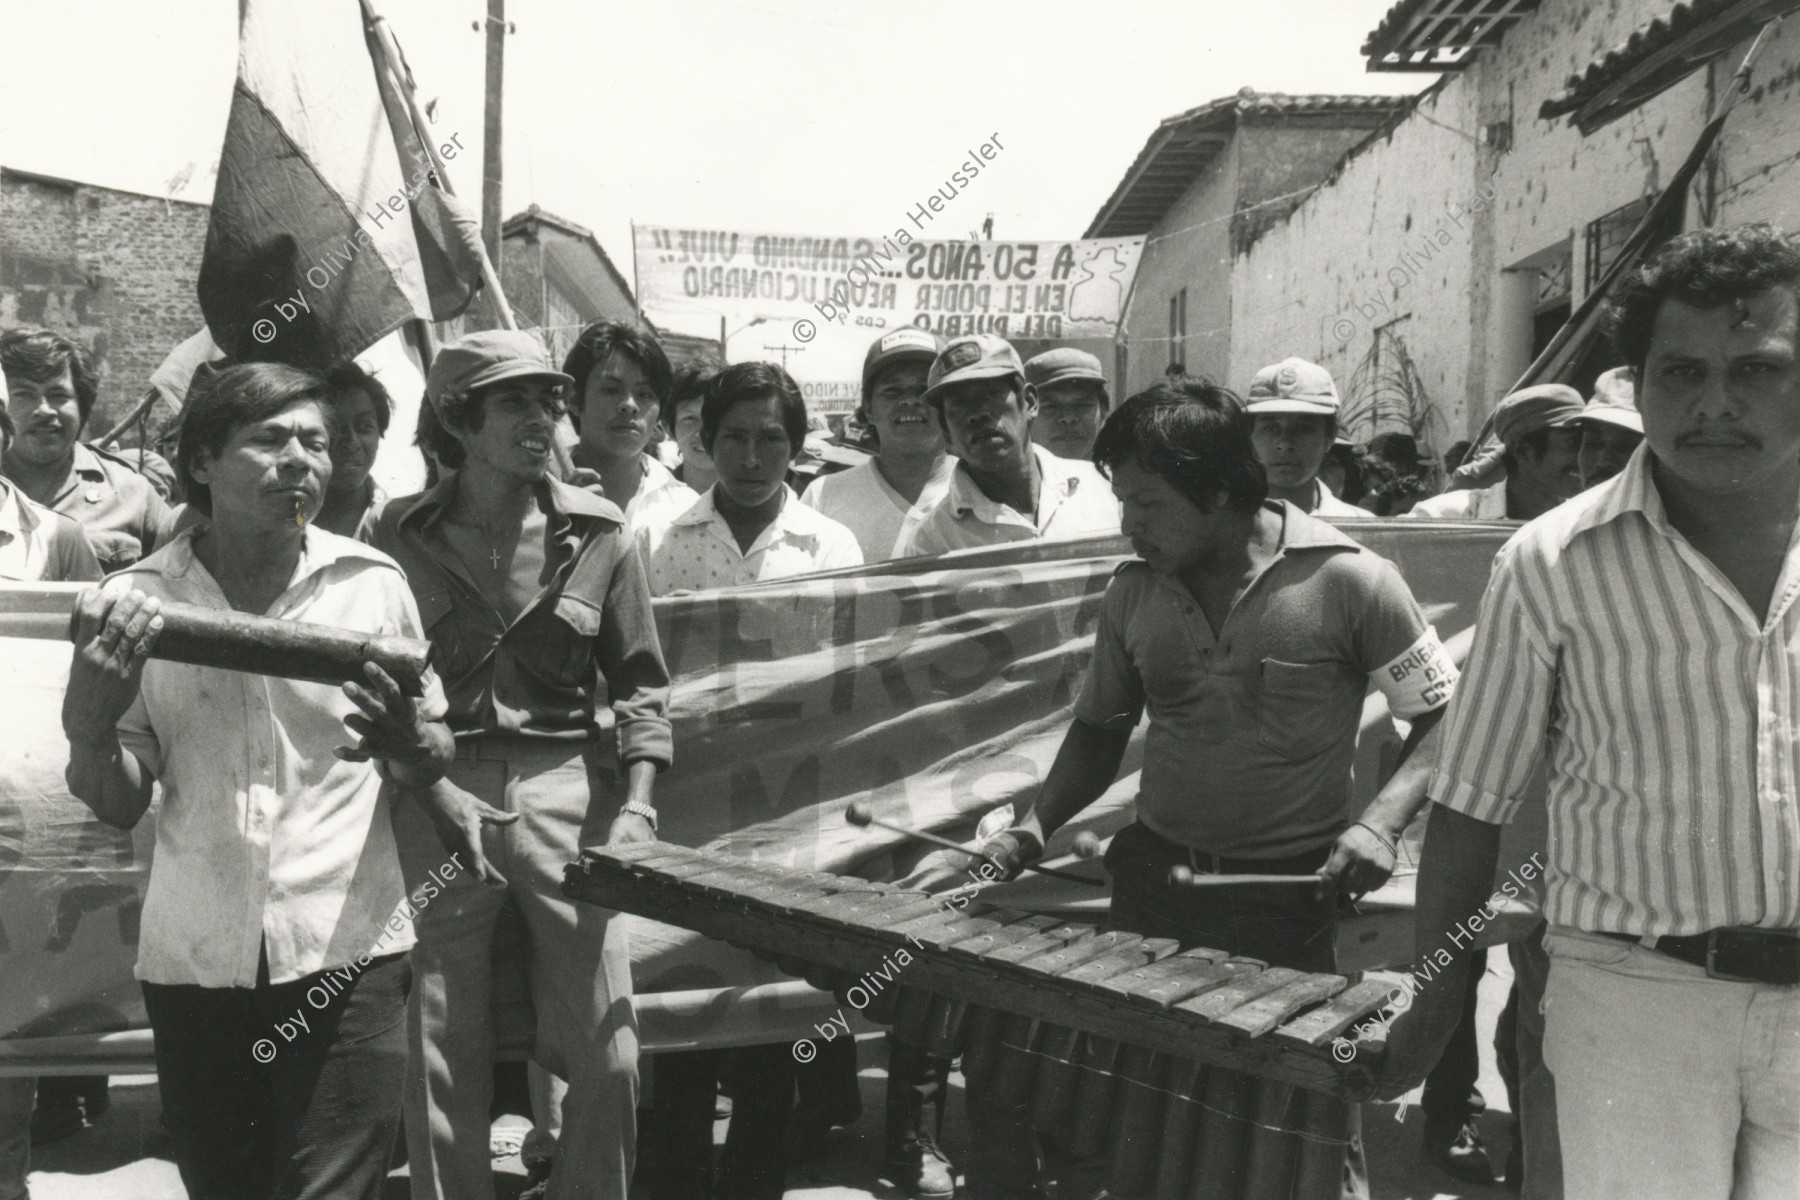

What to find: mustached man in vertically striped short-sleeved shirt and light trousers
left=1384, top=225, right=1800, bottom=1200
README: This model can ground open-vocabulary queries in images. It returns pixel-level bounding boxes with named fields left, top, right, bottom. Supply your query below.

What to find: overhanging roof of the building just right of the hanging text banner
left=1082, top=88, right=1413, bottom=237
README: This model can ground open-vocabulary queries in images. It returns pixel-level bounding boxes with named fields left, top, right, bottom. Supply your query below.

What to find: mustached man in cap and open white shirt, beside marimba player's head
left=895, top=333, right=1120, bottom=558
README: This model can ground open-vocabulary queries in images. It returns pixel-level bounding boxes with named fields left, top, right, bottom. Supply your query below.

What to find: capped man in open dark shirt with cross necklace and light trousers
left=376, top=329, right=671, bottom=1200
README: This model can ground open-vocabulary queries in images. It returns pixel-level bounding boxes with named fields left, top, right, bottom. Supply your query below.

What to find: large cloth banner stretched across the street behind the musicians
left=0, top=522, right=1510, bottom=1038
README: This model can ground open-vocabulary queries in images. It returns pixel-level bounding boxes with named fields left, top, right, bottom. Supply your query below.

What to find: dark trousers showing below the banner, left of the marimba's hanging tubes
left=648, top=1042, right=794, bottom=1200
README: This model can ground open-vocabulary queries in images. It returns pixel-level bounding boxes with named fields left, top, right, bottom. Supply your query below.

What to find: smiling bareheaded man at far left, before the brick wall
left=0, top=329, right=169, bottom=570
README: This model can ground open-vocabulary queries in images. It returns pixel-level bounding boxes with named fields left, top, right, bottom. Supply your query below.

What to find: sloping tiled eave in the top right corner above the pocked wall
left=1537, top=0, right=1800, bottom=133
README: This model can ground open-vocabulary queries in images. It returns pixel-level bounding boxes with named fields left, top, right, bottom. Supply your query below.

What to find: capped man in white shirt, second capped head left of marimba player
left=801, top=326, right=956, bottom=563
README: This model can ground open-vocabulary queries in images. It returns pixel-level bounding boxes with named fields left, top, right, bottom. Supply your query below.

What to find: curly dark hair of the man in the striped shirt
left=1606, top=223, right=1800, bottom=378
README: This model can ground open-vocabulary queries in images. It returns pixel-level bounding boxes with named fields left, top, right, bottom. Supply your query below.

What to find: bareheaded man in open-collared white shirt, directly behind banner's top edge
left=637, top=362, right=862, bottom=596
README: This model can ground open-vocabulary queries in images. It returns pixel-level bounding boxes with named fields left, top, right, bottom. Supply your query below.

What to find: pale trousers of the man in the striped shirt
left=1544, top=927, right=1800, bottom=1200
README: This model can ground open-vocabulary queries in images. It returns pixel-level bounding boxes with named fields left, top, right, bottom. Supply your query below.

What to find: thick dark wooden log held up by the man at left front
left=0, top=583, right=430, bottom=696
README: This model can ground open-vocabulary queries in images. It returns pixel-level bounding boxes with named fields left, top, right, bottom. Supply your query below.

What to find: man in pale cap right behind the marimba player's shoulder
left=1244, top=358, right=1368, bottom=518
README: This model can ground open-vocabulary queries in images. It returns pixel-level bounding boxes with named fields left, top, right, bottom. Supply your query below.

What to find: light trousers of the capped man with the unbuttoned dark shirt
left=394, top=738, right=637, bottom=1200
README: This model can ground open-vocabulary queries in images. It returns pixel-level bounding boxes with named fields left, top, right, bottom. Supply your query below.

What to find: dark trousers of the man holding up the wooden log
left=144, top=954, right=412, bottom=1200
